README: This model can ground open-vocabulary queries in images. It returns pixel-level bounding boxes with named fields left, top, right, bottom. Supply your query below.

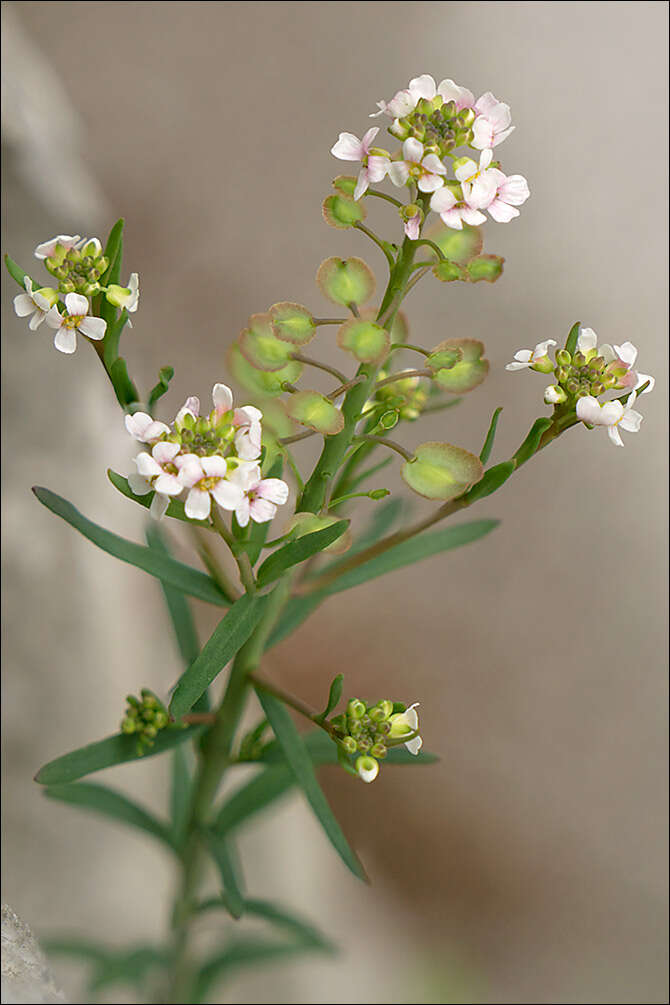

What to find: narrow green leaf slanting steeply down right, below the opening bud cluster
left=256, top=687, right=367, bottom=879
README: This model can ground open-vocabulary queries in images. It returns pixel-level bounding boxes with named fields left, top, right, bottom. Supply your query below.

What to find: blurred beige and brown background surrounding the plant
left=2, top=2, right=667, bottom=1003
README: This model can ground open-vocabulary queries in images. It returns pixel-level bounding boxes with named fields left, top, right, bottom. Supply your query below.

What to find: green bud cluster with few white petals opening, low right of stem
left=328, top=697, right=422, bottom=782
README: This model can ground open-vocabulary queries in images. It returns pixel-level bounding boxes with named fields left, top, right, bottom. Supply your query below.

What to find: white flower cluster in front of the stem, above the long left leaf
left=126, top=384, right=288, bottom=527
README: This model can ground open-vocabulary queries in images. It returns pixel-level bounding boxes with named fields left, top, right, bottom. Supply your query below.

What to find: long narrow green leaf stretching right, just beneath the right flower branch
left=313, top=520, right=499, bottom=594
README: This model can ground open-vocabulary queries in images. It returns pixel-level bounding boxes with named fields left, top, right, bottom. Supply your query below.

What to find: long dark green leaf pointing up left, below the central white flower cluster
left=33, top=486, right=228, bottom=607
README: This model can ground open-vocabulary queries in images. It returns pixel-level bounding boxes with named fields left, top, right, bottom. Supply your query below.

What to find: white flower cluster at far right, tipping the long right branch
left=505, top=328, right=655, bottom=446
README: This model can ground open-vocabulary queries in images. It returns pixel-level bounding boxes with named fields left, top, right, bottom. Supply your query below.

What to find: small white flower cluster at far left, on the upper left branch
left=14, top=234, right=140, bottom=353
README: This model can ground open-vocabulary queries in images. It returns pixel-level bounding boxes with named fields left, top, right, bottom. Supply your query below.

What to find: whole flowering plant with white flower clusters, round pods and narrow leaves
left=6, top=74, right=654, bottom=1002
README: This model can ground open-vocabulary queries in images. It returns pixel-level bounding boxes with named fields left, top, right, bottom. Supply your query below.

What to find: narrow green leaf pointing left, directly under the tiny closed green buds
left=35, top=726, right=204, bottom=785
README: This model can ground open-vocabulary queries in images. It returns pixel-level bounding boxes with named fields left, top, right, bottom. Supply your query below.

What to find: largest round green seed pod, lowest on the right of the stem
left=401, top=441, right=484, bottom=503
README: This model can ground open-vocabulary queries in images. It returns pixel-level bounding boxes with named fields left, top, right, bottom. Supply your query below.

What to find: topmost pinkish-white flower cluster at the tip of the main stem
left=330, top=73, right=530, bottom=240
